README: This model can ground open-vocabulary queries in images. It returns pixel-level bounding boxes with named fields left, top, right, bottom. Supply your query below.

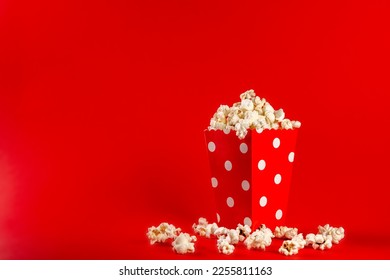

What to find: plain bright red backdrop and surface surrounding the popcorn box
left=0, top=0, right=390, bottom=259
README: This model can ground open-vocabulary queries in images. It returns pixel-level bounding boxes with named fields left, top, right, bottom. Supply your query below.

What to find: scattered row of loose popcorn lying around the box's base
left=146, top=218, right=345, bottom=256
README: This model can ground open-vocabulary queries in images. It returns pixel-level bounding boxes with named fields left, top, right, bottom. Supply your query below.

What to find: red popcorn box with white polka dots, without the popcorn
left=205, top=129, right=298, bottom=229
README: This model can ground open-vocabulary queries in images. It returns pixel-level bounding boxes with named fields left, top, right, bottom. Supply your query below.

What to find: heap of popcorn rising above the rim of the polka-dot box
left=208, top=89, right=301, bottom=139
